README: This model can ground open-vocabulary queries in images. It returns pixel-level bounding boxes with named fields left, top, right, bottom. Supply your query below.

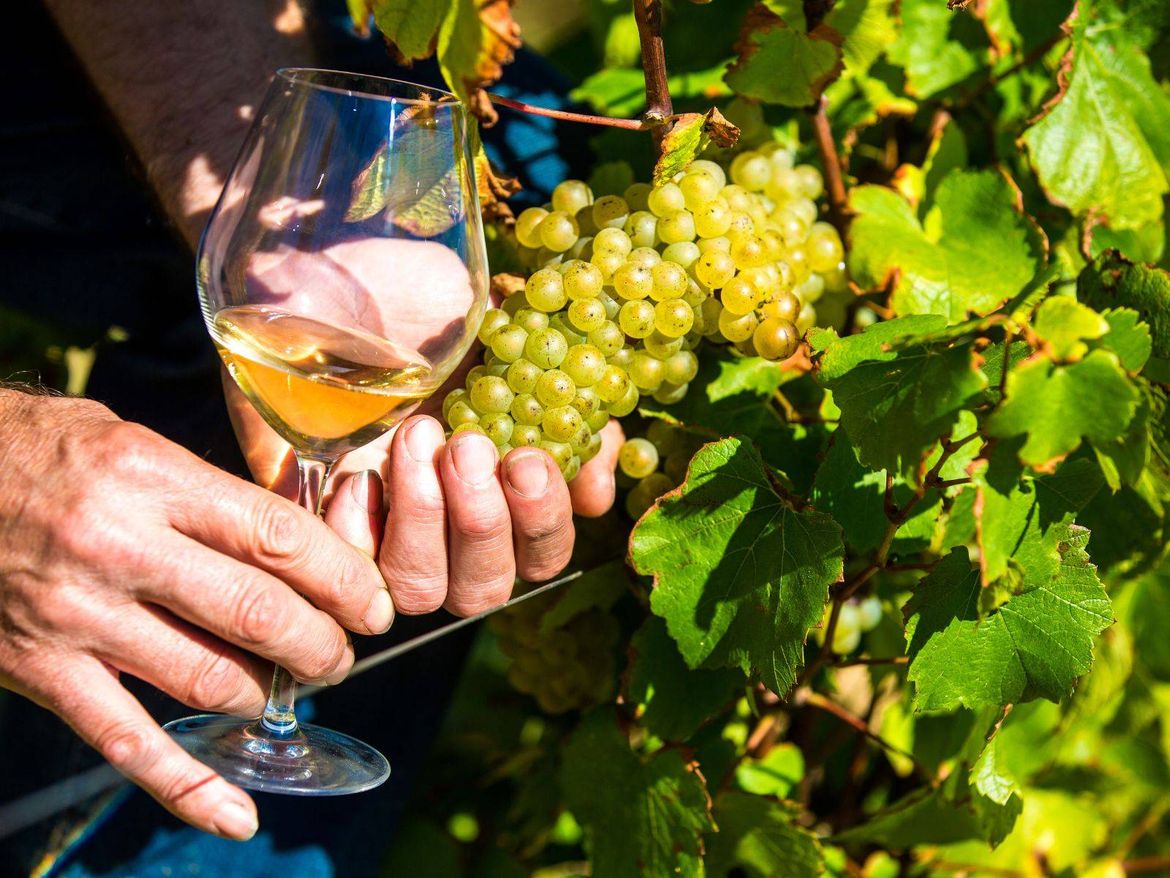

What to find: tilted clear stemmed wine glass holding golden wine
left=166, top=68, right=488, bottom=795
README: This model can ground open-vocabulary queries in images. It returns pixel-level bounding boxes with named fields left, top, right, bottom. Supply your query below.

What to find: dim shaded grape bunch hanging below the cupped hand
left=488, top=597, right=619, bottom=713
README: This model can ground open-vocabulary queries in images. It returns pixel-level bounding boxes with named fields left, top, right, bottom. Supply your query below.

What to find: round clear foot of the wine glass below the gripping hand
left=163, top=713, right=390, bottom=796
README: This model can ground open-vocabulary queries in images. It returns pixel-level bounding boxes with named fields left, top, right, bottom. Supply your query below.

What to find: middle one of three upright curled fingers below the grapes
left=440, top=432, right=516, bottom=616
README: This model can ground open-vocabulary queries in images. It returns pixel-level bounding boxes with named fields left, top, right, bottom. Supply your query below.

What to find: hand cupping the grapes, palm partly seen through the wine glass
left=225, top=239, right=622, bottom=616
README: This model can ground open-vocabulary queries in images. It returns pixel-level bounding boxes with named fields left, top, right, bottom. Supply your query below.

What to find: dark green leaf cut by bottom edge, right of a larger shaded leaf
left=703, top=793, right=824, bottom=878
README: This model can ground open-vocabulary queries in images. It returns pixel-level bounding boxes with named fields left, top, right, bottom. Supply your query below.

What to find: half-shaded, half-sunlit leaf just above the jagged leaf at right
left=973, top=443, right=1102, bottom=592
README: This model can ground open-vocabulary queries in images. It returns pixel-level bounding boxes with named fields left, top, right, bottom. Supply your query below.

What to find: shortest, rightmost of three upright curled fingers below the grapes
left=503, top=448, right=573, bottom=582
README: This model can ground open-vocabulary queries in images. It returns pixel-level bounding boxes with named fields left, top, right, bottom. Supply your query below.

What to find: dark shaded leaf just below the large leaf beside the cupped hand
left=626, top=616, right=744, bottom=741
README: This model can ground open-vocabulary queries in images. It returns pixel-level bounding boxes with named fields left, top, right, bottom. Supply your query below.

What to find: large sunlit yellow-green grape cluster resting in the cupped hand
left=443, top=143, right=845, bottom=482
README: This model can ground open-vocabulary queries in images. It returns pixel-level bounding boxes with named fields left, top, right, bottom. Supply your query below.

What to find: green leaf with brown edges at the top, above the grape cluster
left=724, top=4, right=844, bottom=107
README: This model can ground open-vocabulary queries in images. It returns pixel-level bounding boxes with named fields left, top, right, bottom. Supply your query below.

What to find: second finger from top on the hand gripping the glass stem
left=139, top=540, right=353, bottom=684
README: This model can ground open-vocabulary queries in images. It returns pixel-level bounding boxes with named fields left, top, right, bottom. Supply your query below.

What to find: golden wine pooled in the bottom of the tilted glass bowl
left=212, top=304, right=434, bottom=454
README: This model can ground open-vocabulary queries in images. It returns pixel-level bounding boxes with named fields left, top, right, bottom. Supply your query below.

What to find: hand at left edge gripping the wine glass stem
left=0, top=390, right=392, bottom=838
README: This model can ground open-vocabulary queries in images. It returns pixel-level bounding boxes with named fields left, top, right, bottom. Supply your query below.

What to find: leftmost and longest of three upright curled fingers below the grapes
left=378, top=417, right=447, bottom=615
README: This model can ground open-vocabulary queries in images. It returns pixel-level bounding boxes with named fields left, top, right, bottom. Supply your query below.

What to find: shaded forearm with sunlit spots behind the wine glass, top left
left=46, top=0, right=312, bottom=247
